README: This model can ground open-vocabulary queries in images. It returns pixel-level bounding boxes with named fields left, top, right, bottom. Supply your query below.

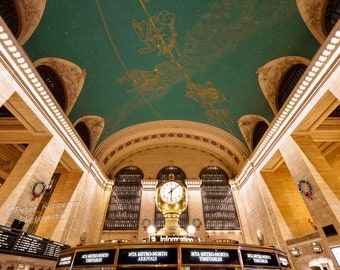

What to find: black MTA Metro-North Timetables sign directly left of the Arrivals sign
left=73, top=249, right=116, bottom=265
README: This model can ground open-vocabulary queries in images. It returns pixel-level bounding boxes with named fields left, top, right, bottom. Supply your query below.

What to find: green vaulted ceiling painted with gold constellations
left=24, top=0, right=319, bottom=144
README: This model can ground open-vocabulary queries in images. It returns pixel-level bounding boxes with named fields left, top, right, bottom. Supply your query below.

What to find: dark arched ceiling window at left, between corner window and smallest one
left=36, top=65, right=66, bottom=111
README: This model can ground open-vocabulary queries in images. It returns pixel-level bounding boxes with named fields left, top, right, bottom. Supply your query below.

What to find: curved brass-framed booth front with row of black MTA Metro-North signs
left=56, top=242, right=291, bottom=270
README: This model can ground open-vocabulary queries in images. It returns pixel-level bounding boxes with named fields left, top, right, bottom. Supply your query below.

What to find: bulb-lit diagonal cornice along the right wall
left=231, top=21, right=340, bottom=188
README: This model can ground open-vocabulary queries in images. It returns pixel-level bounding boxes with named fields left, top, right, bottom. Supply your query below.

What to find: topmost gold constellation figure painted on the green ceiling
left=132, top=10, right=180, bottom=58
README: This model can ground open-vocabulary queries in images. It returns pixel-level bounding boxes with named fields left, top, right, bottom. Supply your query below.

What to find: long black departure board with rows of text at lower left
left=0, top=225, right=68, bottom=260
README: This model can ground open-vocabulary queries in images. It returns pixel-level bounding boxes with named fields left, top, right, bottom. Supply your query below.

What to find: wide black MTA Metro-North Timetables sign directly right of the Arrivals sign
left=182, top=248, right=239, bottom=264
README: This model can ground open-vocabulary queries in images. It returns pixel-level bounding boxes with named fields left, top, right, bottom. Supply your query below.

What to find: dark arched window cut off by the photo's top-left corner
left=0, top=0, right=19, bottom=38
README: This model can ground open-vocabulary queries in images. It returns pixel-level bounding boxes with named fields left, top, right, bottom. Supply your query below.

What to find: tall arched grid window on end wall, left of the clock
left=104, top=166, right=144, bottom=230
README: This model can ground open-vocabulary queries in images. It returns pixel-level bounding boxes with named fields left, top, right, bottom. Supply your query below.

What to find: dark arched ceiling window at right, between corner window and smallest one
left=277, top=64, right=307, bottom=110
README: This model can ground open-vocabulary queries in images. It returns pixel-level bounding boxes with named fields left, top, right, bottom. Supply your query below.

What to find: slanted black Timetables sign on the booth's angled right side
left=241, top=250, right=279, bottom=266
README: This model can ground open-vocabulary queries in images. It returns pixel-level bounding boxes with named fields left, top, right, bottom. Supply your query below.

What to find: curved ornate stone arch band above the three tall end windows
left=94, top=120, right=249, bottom=176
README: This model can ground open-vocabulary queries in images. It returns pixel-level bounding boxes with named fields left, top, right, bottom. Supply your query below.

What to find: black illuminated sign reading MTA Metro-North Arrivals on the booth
left=118, top=248, right=177, bottom=264
